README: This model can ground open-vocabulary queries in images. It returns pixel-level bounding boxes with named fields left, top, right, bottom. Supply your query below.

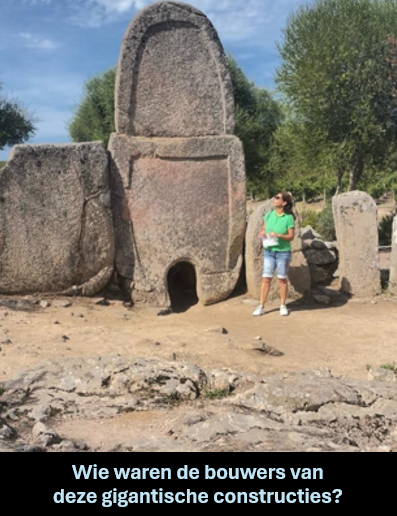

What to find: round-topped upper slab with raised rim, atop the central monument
left=116, top=2, right=234, bottom=137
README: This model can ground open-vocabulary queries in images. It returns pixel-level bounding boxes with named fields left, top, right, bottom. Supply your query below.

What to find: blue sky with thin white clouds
left=0, top=0, right=309, bottom=160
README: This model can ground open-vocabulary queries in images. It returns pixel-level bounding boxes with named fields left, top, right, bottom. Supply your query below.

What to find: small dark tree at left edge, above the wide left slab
left=0, top=83, right=36, bottom=150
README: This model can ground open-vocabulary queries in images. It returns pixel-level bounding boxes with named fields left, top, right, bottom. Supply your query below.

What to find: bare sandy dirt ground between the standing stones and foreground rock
left=0, top=290, right=397, bottom=382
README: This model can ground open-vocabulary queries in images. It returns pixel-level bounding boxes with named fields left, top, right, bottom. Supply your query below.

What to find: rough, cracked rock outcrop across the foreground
left=0, top=356, right=397, bottom=451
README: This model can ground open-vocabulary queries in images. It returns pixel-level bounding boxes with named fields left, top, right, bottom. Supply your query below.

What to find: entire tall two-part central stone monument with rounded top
left=109, top=2, right=246, bottom=306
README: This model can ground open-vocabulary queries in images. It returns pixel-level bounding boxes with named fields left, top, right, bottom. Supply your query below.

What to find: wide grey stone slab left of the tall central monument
left=0, top=142, right=114, bottom=295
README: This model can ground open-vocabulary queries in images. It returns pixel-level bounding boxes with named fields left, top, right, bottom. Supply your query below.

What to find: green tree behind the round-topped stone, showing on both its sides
left=69, top=57, right=282, bottom=196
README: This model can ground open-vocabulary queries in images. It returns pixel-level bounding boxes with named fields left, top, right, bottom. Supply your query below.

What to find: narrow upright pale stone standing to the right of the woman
left=332, top=191, right=381, bottom=297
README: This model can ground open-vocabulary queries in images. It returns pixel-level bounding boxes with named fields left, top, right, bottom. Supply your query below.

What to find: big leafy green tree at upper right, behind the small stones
left=277, top=0, right=397, bottom=190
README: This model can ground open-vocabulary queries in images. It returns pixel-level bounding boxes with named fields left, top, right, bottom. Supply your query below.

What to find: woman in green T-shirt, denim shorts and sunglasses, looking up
left=252, top=192, right=295, bottom=316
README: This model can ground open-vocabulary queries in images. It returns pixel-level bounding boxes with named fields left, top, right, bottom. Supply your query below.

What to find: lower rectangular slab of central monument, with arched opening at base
left=109, top=134, right=246, bottom=306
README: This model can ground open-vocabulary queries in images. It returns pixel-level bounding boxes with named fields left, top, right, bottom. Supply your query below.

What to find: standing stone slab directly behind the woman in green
left=245, top=199, right=311, bottom=299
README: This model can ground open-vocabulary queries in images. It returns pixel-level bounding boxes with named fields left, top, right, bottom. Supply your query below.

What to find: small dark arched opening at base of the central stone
left=167, top=262, right=198, bottom=313
